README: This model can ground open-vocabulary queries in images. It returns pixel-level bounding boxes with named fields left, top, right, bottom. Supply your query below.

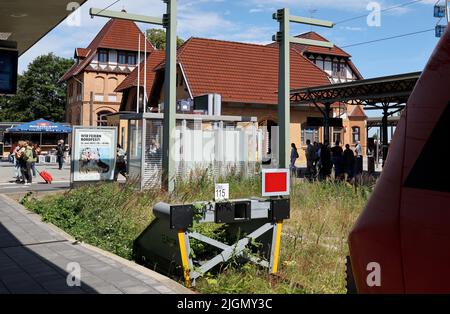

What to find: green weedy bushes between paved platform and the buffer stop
left=22, top=183, right=154, bottom=259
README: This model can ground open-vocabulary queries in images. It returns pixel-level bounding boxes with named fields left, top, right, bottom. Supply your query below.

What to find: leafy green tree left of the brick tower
left=0, top=53, right=73, bottom=122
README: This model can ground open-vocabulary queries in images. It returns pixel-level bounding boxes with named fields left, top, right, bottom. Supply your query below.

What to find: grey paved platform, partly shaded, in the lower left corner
left=0, top=194, right=192, bottom=294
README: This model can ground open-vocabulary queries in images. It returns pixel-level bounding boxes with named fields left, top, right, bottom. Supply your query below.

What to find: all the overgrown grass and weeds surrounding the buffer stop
left=22, top=172, right=371, bottom=293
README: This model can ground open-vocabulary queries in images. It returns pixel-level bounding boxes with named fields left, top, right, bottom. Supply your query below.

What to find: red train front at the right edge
left=349, top=30, right=450, bottom=293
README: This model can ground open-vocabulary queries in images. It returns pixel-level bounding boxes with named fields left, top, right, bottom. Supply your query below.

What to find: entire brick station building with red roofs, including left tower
left=61, top=19, right=367, bottom=163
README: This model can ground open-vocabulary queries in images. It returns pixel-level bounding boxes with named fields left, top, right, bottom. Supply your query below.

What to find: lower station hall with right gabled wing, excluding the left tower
left=116, top=33, right=367, bottom=163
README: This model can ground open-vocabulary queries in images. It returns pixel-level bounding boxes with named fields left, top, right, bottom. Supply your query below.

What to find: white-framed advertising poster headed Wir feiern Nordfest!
left=72, top=127, right=117, bottom=182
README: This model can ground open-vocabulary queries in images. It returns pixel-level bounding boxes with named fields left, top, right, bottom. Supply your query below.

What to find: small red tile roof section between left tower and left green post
left=115, top=50, right=165, bottom=94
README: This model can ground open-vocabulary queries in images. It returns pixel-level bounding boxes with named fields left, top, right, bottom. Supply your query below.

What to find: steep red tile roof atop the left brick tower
left=59, top=19, right=155, bottom=81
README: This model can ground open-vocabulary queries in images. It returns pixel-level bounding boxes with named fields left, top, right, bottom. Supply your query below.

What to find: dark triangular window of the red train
left=405, top=103, right=450, bottom=192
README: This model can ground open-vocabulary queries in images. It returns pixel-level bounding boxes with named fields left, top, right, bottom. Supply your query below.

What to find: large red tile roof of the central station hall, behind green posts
left=121, top=38, right=330, bottom=104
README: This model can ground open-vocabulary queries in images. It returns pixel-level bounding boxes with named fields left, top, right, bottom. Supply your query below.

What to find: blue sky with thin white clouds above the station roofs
left=19, top=0, right=438, bottom=78
